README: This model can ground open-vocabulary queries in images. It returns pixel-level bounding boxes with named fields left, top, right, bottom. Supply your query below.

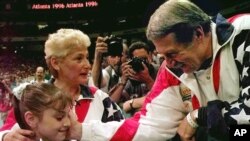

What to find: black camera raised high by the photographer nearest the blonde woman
left=105, top=35, right=123, bottom=56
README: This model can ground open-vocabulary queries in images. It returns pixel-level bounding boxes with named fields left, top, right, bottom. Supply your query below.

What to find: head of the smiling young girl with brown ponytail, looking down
left=14, top=83, right=73, bottom=141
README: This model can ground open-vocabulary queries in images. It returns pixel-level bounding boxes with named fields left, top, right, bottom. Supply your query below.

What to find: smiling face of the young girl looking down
left=33, top=108, right=71, bottom=141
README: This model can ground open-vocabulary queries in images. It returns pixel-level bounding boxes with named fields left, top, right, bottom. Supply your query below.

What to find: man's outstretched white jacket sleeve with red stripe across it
left=81, top=87, right=186, bottom=141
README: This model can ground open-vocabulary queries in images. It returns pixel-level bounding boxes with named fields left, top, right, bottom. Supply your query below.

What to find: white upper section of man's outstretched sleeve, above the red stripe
left=133, top=87, right=186, bottom=141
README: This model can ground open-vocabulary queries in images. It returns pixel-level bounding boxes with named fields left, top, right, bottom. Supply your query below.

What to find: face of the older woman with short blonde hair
left=58, top=48, right=90, bottom=85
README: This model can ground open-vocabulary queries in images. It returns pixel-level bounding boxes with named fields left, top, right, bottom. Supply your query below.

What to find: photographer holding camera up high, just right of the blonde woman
left=92, top=35, right=128, bottom=92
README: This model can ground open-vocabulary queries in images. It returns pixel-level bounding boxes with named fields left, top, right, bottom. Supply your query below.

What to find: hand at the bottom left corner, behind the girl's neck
left=3, top=129, right=36, bottom=141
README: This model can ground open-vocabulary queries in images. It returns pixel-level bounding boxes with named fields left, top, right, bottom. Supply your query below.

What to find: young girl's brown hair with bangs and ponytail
left=13, top=83, right=73, bottom=129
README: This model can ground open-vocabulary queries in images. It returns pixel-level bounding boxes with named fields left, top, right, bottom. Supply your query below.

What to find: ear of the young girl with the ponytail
left=24, top=111, right=39, bottom=129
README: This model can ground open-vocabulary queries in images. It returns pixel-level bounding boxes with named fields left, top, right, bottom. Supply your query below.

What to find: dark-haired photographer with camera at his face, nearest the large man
left=110, top=41, right=157, bottom=116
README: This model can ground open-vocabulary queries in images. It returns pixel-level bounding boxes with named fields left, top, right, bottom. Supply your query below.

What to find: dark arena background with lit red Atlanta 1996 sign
left=0, top=0, right=250, bottom=62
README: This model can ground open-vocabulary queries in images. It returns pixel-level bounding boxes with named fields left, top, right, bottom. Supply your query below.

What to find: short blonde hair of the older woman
left=44, top=28, right=91, bottom=77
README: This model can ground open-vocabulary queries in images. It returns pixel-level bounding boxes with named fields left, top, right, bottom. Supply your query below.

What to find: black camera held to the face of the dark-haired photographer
left=128, top=57, right=149, bottom=72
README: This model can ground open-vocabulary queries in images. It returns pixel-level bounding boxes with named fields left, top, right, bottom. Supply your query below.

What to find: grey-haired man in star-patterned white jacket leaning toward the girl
left=2, top=0, right=250, bottom=141
